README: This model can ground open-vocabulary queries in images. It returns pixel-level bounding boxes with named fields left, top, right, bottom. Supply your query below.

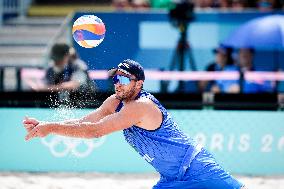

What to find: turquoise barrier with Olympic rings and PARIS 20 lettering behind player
left=0, top=108, right=284, bottom=175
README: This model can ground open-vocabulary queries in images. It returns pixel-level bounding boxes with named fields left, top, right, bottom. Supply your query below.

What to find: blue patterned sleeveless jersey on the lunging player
left=116, top=91, right=201, bottom=181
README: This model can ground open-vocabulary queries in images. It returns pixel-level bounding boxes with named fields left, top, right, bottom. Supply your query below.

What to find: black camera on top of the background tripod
left=169, top=0, right=194, bottom=27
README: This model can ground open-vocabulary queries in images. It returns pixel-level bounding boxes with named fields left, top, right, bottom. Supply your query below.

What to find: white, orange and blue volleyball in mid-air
left=72, top=15, right=106, bottom=48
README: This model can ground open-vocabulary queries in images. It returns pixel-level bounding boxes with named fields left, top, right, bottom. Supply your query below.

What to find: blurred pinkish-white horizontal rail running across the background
left=21, top=68, right=284, bottom=81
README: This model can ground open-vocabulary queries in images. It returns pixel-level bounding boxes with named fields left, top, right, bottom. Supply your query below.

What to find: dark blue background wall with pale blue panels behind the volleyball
left=73, top=11, right=284, bottom=92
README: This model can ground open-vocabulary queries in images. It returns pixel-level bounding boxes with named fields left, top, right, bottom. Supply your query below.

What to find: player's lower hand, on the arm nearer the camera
left=25, top=123, right=51, bottom=140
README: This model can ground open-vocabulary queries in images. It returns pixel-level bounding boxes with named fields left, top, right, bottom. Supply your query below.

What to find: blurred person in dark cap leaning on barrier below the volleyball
left=35, top=43, right=95, bottom=92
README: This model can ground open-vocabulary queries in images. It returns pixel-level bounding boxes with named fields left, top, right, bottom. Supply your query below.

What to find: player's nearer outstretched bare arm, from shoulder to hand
left=26, top=102, right=147, bottom=140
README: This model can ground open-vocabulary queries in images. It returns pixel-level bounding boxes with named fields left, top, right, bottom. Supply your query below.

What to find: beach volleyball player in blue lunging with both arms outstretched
left=23, top=59, right=245, bottom=189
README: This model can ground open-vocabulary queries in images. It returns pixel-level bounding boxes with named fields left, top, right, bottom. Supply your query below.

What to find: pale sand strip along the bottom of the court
left=0, top=172, right=284, bottom=189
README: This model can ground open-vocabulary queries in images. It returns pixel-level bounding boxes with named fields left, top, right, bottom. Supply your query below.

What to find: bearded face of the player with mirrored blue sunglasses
left=113, top=71, right=141, bottom=100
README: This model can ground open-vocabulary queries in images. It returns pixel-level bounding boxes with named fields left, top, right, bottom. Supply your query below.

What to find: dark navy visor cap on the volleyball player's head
left=108, top=59, right=145, bottom=81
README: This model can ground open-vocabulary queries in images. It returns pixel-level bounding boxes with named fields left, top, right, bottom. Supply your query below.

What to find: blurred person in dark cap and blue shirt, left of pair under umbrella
left=199, top=45, right=240, bottom=93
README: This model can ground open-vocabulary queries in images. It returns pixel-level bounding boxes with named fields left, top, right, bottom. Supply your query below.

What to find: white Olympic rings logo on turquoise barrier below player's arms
left=41, top=136, right=106, bottom=158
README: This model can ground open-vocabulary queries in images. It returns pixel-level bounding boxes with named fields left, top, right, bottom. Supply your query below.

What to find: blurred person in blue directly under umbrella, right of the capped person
left=237, top=48, right=275, bottom=93
